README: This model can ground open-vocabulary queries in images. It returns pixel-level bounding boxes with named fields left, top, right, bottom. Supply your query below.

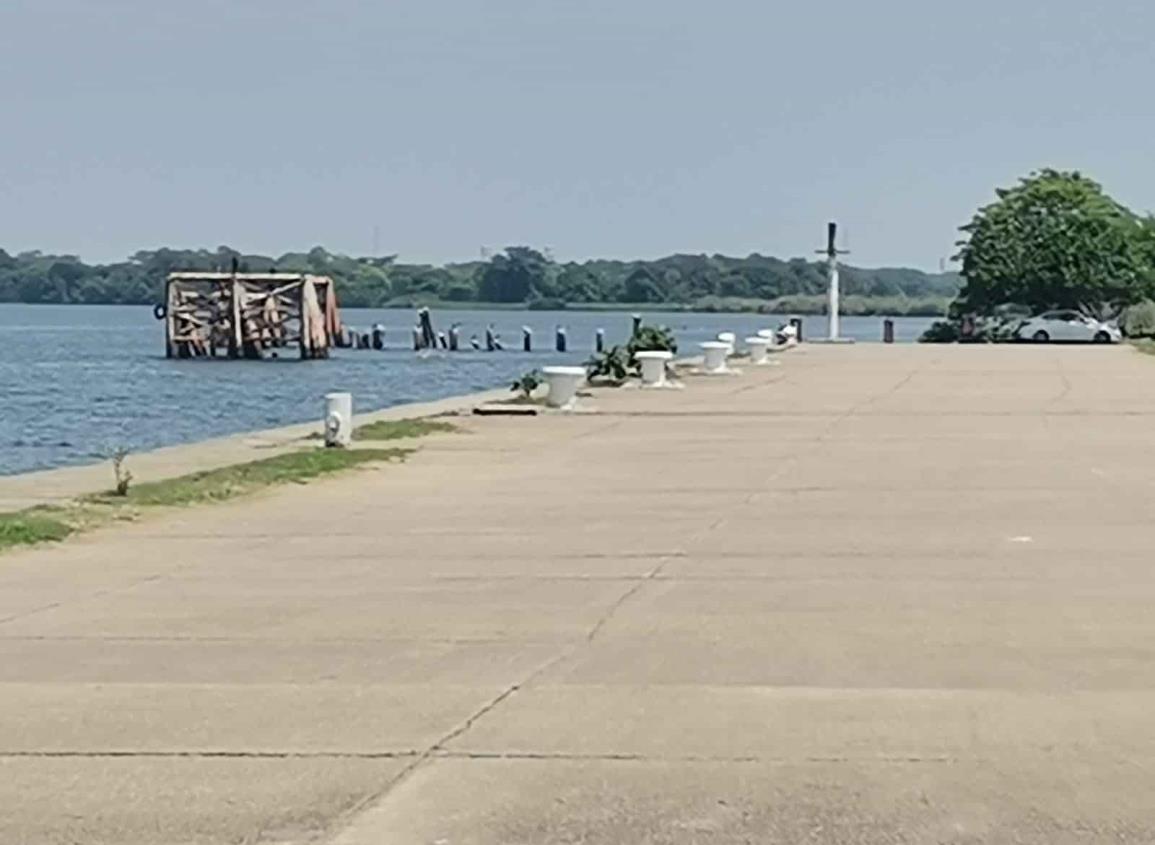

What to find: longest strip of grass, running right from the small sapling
left=85, top=449, right=410, bottom=507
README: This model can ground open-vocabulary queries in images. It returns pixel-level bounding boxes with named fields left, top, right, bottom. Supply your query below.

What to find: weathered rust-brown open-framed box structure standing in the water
left=165, top=272, right=342, bottom=359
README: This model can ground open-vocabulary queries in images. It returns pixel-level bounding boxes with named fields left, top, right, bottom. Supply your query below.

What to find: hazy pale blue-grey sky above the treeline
left=0, top=0, right=1155, bottom=270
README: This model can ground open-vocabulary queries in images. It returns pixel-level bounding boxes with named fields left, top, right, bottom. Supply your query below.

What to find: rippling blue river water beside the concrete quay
left=0, top=305, right=931, bottom=474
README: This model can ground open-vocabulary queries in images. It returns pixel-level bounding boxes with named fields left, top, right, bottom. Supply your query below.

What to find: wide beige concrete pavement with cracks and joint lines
left=0, top=345, right=1155, bottom=845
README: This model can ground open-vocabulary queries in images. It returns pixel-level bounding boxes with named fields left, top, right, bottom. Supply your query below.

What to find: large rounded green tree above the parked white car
left=954, top=170, right=1155, bottom=315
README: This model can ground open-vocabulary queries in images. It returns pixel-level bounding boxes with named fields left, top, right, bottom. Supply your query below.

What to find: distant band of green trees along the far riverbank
left=0, top=246, right=959, bottom=314
